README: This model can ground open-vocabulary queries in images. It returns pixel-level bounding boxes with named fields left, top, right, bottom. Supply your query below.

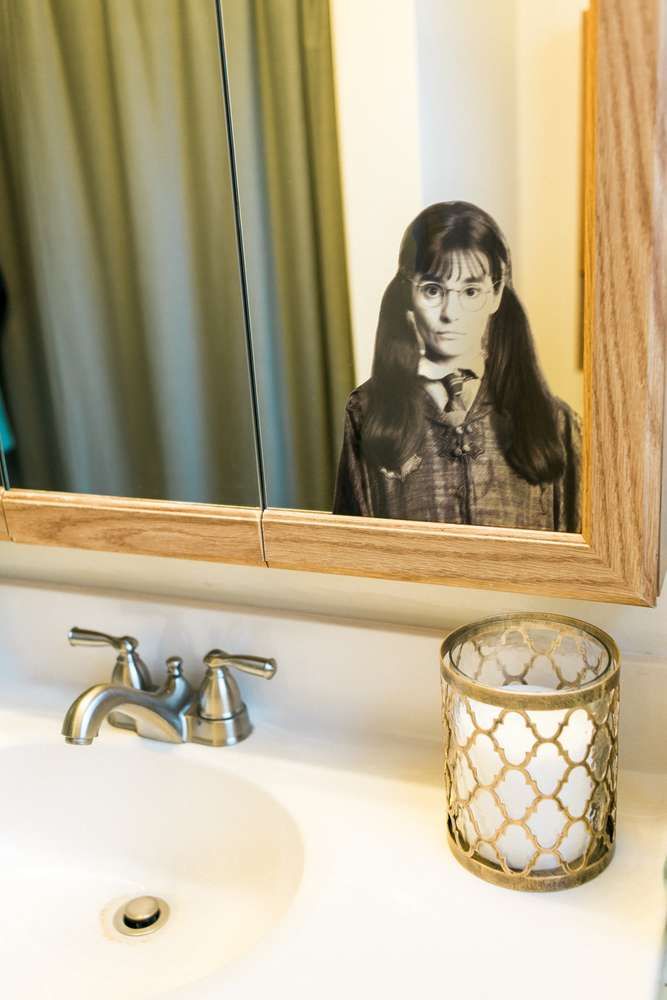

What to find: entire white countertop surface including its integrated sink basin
left=0, top=699, right=667, bottom=1000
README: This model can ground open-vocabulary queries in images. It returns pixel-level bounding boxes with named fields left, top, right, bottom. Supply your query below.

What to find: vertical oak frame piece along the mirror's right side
left=584, top=0, right=667, bottom=604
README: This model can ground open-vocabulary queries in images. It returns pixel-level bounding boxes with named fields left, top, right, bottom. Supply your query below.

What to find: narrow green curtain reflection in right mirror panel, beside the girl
left=222, top=0, right=355, bottom=510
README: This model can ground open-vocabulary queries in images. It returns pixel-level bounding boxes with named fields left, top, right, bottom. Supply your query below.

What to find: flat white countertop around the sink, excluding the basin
left=0, top=698, right=667, bottom=1000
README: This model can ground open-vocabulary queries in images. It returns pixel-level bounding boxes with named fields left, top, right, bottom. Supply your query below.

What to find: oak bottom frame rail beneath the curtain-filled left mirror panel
left=2, top=490, right=265, bottom=566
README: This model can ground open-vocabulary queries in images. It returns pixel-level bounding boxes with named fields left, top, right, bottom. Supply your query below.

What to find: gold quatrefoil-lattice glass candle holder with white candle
left=441, top=613, right=619, bottom=891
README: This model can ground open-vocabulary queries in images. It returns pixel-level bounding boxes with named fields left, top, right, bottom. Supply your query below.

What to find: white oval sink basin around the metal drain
left=0, top=733, right=303, bottom=1000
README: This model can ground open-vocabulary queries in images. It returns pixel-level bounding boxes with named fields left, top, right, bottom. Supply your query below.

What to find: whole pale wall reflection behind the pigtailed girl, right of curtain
left=331, top=0, right=586, bottom=413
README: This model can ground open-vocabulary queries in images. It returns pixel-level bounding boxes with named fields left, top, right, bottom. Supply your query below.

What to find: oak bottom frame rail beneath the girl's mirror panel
left=262, top=508, right=650, bottom=604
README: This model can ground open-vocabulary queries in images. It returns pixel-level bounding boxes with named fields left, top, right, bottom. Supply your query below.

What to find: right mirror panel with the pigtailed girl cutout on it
left=221, top=0, right=586, bottom=532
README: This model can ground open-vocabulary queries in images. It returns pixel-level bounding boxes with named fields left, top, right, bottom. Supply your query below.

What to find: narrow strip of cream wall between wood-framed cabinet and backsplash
left=0, top=542, right=667, bottom=669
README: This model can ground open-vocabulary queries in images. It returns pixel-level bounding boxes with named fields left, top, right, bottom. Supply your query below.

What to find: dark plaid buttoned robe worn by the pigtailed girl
left=333, top=380, right=581, bottom=532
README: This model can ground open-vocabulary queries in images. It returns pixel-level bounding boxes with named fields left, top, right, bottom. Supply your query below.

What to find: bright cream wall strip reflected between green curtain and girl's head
left=331, top=0, right=423, bottom=384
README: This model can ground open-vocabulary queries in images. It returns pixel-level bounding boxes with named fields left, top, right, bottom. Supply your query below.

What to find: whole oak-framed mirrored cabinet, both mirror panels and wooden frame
left=0, top=0, right=665, bottom=605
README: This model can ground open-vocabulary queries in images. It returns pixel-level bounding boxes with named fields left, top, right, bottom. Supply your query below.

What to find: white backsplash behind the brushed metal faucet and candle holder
left=0, top=572, right=667, bottom=783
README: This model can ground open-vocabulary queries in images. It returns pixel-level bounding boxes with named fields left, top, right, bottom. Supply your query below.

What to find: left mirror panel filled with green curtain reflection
left=0, top=0, right=260, bottom=506
